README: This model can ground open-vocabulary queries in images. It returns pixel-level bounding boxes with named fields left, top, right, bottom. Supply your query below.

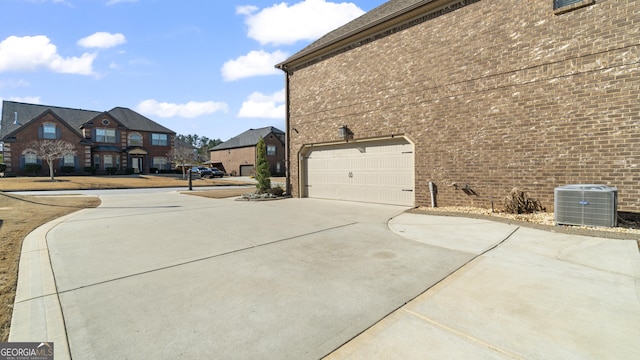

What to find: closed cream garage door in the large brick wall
left=303, top=139, right=414, bottom=206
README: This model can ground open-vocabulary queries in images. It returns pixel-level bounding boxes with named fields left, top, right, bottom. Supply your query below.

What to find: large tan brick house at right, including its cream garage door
left=276, top=0, right=640, bottom=212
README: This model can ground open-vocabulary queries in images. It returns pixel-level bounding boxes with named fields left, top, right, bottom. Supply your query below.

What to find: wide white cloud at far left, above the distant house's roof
left=0, top=35, right=97, bottom=75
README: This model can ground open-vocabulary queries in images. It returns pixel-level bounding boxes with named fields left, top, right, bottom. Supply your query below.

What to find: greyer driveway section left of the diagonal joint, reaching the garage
left=11, top=192, right=473, bottom=359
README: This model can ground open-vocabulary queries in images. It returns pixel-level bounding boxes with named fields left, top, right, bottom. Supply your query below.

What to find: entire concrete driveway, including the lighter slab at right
left=9, top=191, right=640, bottom=360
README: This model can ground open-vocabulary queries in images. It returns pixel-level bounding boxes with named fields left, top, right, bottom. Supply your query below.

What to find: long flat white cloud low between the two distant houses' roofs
left=136, top=99, right=229, bottom=118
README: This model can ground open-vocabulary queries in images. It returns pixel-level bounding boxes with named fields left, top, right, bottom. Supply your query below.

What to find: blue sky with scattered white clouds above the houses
left=0, top=0, right=386, bottom=141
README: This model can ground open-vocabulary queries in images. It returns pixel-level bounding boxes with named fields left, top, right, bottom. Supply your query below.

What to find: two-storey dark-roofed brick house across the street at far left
left=0, top=101, right=175, bottom=175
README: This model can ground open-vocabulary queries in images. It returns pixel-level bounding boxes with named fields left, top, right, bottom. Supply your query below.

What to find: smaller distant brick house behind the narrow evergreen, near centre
left=211, top=126, right=285, bottom=176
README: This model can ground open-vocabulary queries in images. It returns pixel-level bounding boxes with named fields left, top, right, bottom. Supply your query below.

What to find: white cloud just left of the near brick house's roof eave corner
left=221, top=50, right=289, bottom=81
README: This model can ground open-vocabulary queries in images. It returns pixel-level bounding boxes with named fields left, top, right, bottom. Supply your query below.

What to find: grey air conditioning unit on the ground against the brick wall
left=553, top=185, right=618, bottom=227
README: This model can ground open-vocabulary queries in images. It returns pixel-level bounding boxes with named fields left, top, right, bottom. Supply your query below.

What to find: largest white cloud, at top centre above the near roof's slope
left=236, top=0, right=364, bottom=45
